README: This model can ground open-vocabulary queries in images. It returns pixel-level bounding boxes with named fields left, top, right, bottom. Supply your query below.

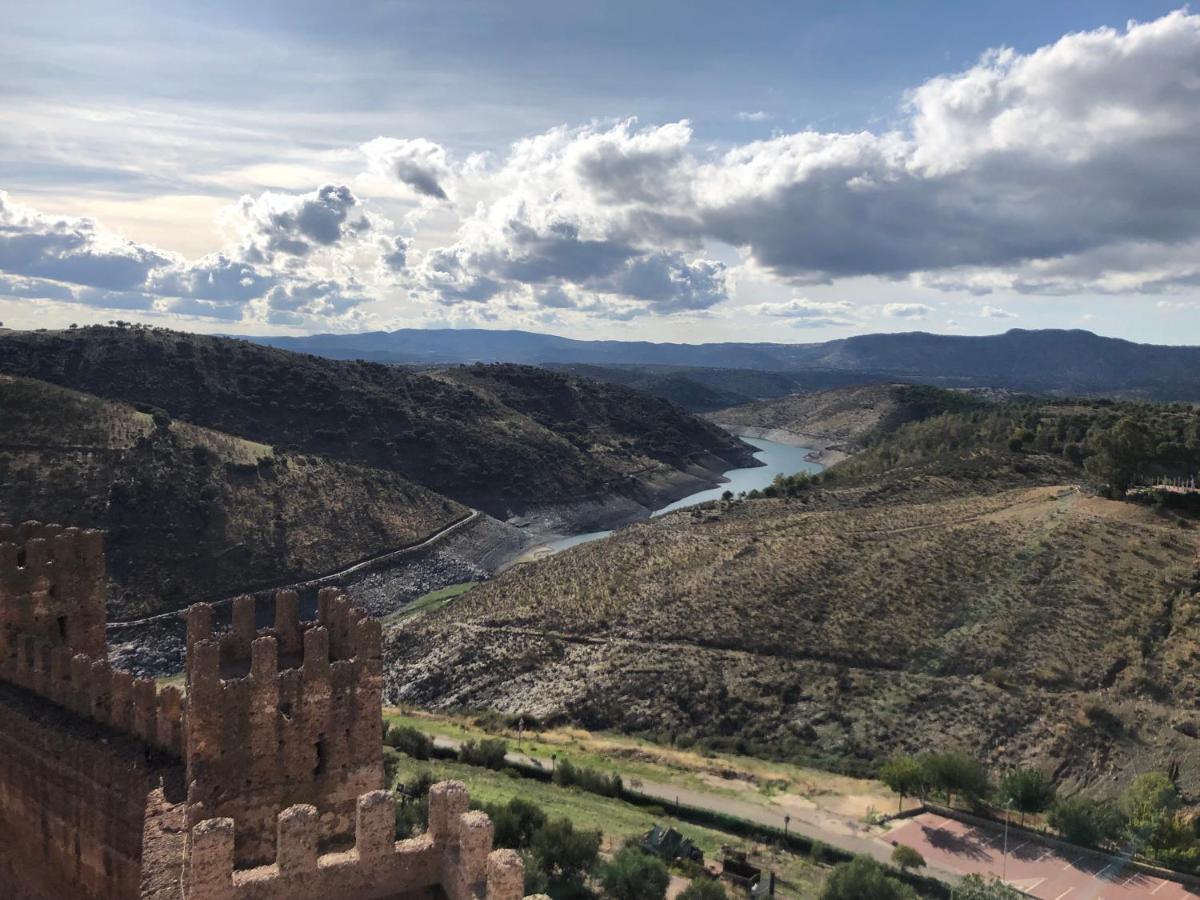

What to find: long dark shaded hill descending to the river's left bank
left=0, top=328, right=750, bottom=527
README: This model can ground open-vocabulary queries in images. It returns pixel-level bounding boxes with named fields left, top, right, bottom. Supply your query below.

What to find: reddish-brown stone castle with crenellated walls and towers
left=0, top=522, right=524, bottom=900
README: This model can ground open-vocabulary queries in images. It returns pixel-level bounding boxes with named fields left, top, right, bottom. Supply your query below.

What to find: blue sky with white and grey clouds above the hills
left=0, top=0, right=1200, bottom=343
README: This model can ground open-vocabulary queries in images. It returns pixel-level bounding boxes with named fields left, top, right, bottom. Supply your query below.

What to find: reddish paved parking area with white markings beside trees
left=887, top=812, right=1200, bottom=900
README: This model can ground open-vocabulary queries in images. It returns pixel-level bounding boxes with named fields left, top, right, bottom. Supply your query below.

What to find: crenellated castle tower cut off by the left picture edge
left=0, top=522, right=108, bottom=659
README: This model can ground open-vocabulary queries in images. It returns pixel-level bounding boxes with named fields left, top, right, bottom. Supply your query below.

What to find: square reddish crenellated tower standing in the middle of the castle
left=185, top=589, right=383, bottom=864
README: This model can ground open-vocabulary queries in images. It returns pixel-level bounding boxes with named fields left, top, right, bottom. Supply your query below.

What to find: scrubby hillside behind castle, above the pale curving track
left=0, top=376, right=468, bottom=620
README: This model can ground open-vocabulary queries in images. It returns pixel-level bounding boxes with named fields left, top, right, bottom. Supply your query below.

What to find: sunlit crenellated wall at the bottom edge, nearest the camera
left=184, top=781, right=524, bottom=900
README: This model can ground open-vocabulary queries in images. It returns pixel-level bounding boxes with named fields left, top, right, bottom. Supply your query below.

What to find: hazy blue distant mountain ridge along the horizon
left=247, top=329, right=1200, bottom=402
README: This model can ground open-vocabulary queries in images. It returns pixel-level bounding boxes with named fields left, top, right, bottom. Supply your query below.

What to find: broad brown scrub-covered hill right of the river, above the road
left=388, top=403, right=1200, bottom=793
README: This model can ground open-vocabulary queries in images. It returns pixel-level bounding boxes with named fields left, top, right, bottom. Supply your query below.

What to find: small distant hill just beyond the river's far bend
left=704, top=384, right=985, bottom=462
